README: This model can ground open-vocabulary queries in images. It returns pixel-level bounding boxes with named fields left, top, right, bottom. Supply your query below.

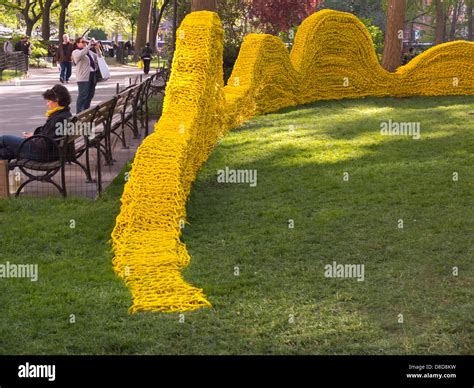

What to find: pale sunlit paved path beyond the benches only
left=0, top=66, right=143, bottom=136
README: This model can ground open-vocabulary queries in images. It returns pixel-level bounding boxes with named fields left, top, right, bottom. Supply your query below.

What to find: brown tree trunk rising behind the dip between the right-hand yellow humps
left=382, top=0, right=406, bottom=71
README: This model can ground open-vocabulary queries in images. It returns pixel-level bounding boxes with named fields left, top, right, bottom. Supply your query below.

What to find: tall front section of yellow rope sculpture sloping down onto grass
left=112, top=12, right=225, bottom=312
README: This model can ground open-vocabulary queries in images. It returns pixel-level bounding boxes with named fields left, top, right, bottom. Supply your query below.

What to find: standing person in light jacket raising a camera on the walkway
left=72, top=37, right=102, bottom=113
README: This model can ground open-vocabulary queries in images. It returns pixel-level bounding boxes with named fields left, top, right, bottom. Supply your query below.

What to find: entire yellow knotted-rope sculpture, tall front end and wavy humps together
left=112, top=10, right=474, bottom=312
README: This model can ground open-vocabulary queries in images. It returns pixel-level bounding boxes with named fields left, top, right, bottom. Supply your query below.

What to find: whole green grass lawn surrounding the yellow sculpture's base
left=0, top=96, right=474, bottom=354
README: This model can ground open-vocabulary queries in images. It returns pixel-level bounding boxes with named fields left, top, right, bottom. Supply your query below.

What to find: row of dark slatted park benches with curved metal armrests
left=3, top=67, right=164, bottom=197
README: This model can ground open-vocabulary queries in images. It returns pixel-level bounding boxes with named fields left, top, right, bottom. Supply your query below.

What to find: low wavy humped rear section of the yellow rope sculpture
left=225, top=10, right=474, bottom=117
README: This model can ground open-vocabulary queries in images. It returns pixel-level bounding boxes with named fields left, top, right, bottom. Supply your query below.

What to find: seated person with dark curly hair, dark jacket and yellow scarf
left=0, top=85, right=72, bottom=162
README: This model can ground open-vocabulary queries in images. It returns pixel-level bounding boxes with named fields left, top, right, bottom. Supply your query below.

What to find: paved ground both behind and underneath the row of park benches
left=0, top=66, right=160, bottom=198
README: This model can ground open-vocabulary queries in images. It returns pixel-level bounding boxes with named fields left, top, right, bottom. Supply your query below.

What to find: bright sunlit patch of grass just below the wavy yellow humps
left=220, top=101, right=466, bottom=167
